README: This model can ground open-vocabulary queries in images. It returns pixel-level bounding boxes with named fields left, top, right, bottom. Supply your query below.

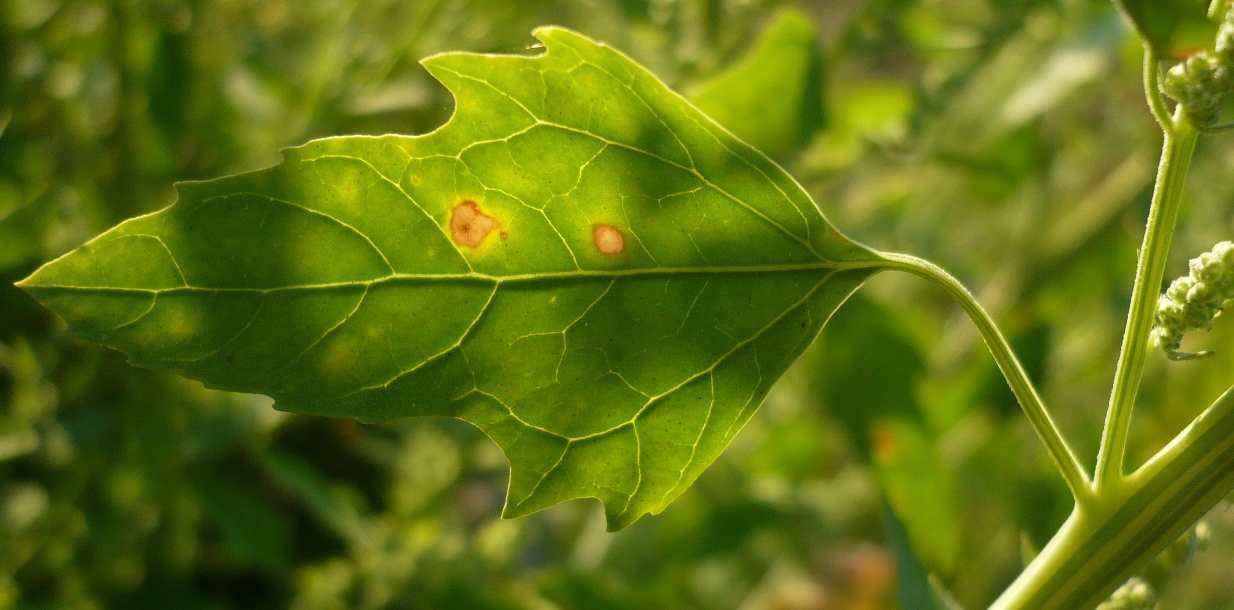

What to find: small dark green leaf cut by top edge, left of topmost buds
left=1114, top=0, right=1217, bottom=58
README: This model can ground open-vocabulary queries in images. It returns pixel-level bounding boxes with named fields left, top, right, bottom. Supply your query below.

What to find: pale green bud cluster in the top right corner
left=1161, top=10, right=1234, bottom=127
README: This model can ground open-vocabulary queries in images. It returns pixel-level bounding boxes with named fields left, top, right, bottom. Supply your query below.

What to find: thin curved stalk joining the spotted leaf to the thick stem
left=882, top=253, right=1093, bottom=504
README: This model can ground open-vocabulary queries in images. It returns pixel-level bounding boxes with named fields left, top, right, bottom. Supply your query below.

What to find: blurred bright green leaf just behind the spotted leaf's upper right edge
left=692, top=9, right=824, bottom=156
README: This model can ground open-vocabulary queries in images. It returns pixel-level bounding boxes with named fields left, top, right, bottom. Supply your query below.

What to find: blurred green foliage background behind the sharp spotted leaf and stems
left=7, top=0, right=1234, bottom=610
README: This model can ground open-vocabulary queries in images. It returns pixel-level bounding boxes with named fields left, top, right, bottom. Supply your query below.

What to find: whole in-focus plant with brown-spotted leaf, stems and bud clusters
left=20, top=1, right=1234, bottom=609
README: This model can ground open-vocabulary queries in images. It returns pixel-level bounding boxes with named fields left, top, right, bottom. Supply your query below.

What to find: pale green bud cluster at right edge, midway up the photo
left=1151, top=242, right=1234, bottom=361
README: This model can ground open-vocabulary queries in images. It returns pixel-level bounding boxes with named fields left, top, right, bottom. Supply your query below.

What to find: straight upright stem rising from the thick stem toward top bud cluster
left=1096, top=111, right=1198, bottom=493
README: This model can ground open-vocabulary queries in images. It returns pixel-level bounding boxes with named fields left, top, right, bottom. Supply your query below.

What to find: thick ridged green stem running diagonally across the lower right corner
left=990, top=389, right=1234, bottom=610
